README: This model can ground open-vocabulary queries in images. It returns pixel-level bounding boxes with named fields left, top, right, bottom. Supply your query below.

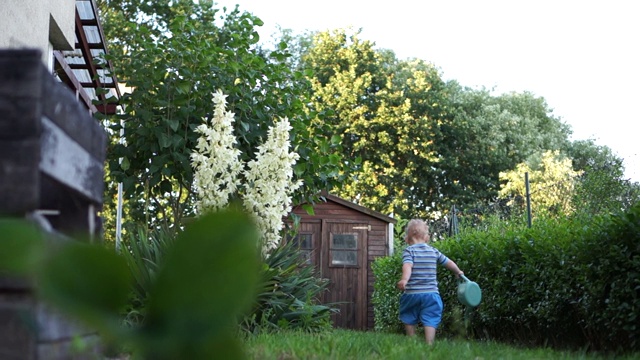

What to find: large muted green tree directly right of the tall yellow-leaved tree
left=437, top=81, right=570, bottom=211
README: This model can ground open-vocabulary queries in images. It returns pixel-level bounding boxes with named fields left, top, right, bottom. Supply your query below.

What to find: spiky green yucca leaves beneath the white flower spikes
left=121, top=222, right=337, bottom=333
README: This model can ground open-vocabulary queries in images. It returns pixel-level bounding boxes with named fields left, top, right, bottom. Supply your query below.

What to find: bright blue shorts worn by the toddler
left=398, top=292, right=444, bottom=329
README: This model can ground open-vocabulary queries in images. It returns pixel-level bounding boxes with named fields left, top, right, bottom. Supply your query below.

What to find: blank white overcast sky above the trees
left=214, top=0, right=640, bottom=181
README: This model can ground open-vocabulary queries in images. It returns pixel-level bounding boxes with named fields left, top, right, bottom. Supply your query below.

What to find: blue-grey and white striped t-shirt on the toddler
left=402, top=243, right=449, bottom=294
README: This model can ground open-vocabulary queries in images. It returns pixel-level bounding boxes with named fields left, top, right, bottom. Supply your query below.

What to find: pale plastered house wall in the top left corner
left=0, top=0, right=76, bottom=66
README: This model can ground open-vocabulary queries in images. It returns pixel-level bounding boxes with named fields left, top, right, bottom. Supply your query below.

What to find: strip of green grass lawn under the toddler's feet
left=245, top=330, right=638, bottom=360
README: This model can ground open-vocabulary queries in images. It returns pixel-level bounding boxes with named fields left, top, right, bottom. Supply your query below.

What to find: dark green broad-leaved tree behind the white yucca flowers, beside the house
left=98, top=0, right=343, bottom=229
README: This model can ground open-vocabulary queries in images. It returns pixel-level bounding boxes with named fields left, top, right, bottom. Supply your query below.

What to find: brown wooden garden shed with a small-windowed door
left=292, top=194, right=396, bottom=330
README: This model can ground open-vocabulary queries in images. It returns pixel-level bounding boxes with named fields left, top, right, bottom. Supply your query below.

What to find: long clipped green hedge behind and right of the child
left=373, top=204, right=640, bottom=351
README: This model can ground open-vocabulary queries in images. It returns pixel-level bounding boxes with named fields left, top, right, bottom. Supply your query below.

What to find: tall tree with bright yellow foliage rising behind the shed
left=302, top=29, right=442, bottom=214
